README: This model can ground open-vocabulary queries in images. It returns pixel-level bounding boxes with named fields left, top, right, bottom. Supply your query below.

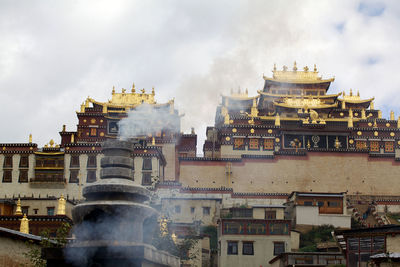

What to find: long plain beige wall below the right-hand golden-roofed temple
left=179, top=152, right=400, bottom=195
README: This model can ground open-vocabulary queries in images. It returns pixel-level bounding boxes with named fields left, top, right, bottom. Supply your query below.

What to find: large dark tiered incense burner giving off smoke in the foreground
left=54, top=140, right=179, bottom=266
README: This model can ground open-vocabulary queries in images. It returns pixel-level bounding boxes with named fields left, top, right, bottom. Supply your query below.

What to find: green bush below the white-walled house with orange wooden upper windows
left=299, top=225, right=335, bottom=252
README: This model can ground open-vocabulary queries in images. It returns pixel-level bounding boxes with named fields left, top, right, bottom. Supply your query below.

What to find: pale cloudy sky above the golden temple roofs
left=0, top=0, right=400, bottom=155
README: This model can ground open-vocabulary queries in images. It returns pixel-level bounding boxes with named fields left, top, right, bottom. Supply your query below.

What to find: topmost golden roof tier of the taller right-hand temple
left=264, top=62, right=335, bottom=84
